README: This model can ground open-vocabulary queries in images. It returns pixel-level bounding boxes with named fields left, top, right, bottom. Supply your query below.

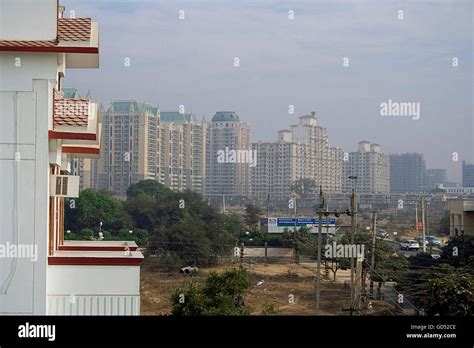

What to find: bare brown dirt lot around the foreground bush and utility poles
left=141, top=262, right=396, bottom=315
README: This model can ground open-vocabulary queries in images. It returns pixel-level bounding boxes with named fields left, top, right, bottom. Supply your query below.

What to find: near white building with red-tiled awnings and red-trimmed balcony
left=0, top=0, right=143, bottom=315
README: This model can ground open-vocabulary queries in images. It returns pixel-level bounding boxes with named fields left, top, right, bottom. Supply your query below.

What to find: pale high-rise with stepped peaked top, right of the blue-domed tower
left=250, top=112, right=342, bottom=201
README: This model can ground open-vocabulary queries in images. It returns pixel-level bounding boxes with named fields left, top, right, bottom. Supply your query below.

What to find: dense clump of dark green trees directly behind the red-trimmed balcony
left=65, top=180, right=242, bottom=268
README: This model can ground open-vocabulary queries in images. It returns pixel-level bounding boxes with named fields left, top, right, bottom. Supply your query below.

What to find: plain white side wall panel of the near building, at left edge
left=0, top=80, right=52, bottom=314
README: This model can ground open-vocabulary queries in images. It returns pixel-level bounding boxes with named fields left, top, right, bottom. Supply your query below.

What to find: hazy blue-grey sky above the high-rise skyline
left=61, top=0, right=474, bottom=182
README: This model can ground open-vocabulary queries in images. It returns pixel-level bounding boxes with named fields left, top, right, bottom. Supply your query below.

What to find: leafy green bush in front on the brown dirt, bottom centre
left=171, top=268, right=251, bottom=316
